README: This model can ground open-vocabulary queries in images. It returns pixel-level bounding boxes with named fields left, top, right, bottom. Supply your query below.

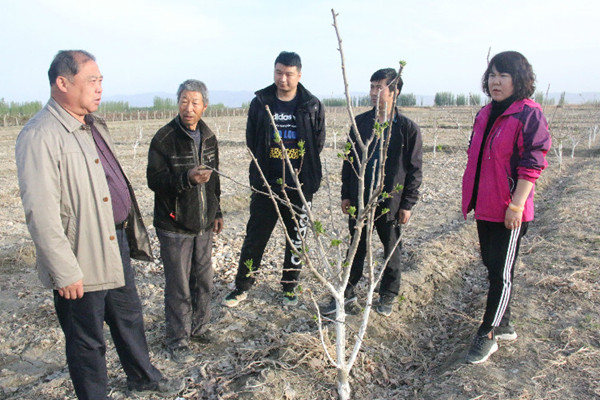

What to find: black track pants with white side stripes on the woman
left=477, top=220, right=529, bottom=336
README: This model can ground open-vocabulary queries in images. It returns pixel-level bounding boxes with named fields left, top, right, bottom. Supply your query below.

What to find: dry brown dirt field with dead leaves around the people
left=0, top=106, right=600, bottom=400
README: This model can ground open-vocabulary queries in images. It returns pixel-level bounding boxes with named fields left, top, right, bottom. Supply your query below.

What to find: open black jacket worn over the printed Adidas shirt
left=246, top=83, right=325, bottom=194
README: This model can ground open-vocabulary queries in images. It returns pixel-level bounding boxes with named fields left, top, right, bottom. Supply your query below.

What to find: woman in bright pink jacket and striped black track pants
left=462, top=51, right=551, bottom=364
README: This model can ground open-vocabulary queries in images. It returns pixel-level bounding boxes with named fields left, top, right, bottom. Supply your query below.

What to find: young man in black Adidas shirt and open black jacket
left=223, top=51, right=325, bottom=307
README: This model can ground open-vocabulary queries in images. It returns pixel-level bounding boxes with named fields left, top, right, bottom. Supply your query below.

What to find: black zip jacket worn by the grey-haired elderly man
left=146, top=116, right=221, bottom=234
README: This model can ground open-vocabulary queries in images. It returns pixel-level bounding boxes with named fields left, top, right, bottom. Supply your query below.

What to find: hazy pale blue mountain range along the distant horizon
left=104, top=90, right=600, bottom=107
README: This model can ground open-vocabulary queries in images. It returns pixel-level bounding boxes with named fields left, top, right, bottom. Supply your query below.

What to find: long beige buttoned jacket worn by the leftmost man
left=15, top=99, right=152, bottom=292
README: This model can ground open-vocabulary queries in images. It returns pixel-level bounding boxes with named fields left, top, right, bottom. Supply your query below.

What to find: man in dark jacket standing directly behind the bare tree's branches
left=321, top=68, right=423, bottom=316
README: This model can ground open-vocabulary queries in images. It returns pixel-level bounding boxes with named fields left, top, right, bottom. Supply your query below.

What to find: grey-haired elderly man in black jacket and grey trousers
left=147, top=79, right=223, bottom=362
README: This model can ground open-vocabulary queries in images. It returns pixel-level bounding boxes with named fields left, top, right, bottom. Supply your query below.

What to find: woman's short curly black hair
left=481, top=51, right=535, bottom=100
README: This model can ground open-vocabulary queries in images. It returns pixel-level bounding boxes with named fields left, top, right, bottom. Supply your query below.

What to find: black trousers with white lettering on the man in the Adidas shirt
left=235, top=191, right=312, bottom=292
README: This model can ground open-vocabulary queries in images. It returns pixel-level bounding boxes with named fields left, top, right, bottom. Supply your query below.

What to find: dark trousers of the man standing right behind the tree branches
left=346, top=212, right=402, bottom=297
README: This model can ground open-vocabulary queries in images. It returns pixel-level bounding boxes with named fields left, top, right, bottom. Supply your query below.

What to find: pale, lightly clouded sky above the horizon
left=0, top=0, right=600, bottom=102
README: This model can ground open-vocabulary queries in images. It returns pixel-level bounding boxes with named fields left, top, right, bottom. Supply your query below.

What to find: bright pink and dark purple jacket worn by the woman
left=462, top=99, right=551, bottom=222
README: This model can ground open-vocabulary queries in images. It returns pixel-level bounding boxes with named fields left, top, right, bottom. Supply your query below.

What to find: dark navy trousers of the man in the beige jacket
left=54, top=229, right=162, bottom=400
